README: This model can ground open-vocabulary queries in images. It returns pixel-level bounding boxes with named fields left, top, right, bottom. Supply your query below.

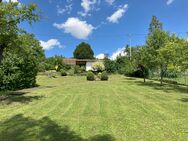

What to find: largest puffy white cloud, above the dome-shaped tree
left=53, top=17, right=94, bottom=39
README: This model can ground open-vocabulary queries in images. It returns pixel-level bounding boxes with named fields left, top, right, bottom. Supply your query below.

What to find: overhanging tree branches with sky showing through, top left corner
left=0, top=1, right=40, bottom=62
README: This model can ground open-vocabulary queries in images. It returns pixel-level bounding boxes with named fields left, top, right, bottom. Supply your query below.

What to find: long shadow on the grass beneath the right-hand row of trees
left=124, top=78, right=188, bottom=94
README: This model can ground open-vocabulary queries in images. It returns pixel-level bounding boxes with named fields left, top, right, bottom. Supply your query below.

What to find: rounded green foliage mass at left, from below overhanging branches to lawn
left=0, top=34, right=44, bottom=90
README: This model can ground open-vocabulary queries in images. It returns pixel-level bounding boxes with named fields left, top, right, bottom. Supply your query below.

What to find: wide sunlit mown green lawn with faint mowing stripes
left=0, top=75, right=188, bottom=141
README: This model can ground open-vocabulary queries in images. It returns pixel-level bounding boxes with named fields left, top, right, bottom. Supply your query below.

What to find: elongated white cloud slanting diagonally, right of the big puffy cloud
left=107, top=4, right=128, bottom=23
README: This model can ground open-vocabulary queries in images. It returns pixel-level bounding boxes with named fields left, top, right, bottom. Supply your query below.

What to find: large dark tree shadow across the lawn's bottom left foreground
left=0, top=114, right=115, bottom=141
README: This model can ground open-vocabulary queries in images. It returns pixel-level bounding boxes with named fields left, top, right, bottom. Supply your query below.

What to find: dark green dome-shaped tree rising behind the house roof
left=73, top=42, right=94, bottom=59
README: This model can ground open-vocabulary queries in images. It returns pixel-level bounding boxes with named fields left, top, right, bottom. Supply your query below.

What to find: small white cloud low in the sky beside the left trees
left=40, top=39, right=63, bottom=50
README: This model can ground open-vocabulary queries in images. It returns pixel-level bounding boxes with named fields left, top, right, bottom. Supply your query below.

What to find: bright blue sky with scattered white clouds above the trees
left=19, top=0, right=188, bottom=58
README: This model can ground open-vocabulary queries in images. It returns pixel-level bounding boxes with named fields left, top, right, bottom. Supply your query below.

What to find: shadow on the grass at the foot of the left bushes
left=0, top=91, right=43, bottom=104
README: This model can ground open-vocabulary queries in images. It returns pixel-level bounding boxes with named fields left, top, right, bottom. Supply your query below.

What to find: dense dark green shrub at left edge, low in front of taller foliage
left=0, top=50, right=38, bottom=90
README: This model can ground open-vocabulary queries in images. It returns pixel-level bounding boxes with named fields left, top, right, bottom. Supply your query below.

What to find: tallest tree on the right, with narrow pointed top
left=145, top=17, right=169, bottom=84
